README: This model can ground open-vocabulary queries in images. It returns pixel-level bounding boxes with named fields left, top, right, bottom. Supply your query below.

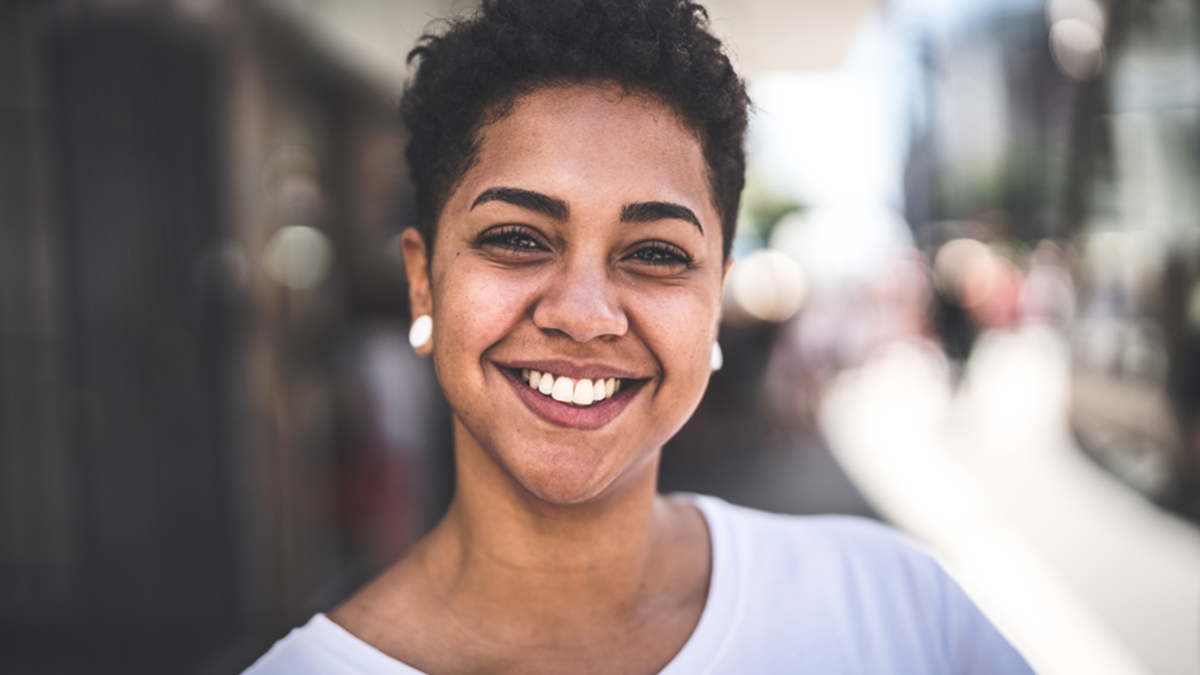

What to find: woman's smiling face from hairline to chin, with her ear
left=406, top=84, right=725, bottom=503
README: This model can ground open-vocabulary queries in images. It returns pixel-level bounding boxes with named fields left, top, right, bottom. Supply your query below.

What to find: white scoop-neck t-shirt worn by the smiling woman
left=244, top=496, right=1032, bottom=675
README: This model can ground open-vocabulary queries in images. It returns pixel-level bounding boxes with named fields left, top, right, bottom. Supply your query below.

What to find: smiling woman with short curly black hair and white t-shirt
left=247, top=0, right=1028, bottom=675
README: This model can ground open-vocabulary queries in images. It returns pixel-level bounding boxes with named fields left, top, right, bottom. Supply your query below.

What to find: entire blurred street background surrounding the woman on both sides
left=0, top=0, right=1200, bottom=675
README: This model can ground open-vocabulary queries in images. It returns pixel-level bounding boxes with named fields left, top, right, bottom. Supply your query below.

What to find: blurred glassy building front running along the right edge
left=1066, top=0, right=1200, bottom=521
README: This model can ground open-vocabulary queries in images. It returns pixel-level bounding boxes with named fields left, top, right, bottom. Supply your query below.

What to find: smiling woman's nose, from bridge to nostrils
left=533, top=253, right=629, bottom=342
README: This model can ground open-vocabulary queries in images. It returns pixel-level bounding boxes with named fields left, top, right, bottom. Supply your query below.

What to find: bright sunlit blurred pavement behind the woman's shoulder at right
left=822, top=327, right=1200, bottom=675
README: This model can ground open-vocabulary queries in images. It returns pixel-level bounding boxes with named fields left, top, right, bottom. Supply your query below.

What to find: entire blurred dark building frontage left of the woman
left=0, top=1, right=450, bottom=673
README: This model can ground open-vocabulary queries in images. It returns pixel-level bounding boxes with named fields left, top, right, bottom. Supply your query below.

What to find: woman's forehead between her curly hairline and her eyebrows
left=448, top=83, right=719, bottom=218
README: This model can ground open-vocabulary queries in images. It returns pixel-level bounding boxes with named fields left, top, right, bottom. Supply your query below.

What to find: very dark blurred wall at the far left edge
left=0, top=2, right=238, bottom=673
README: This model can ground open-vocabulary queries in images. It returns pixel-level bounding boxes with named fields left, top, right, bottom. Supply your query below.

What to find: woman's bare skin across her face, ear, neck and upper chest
left=330, top=84, right=727, bottom=675
